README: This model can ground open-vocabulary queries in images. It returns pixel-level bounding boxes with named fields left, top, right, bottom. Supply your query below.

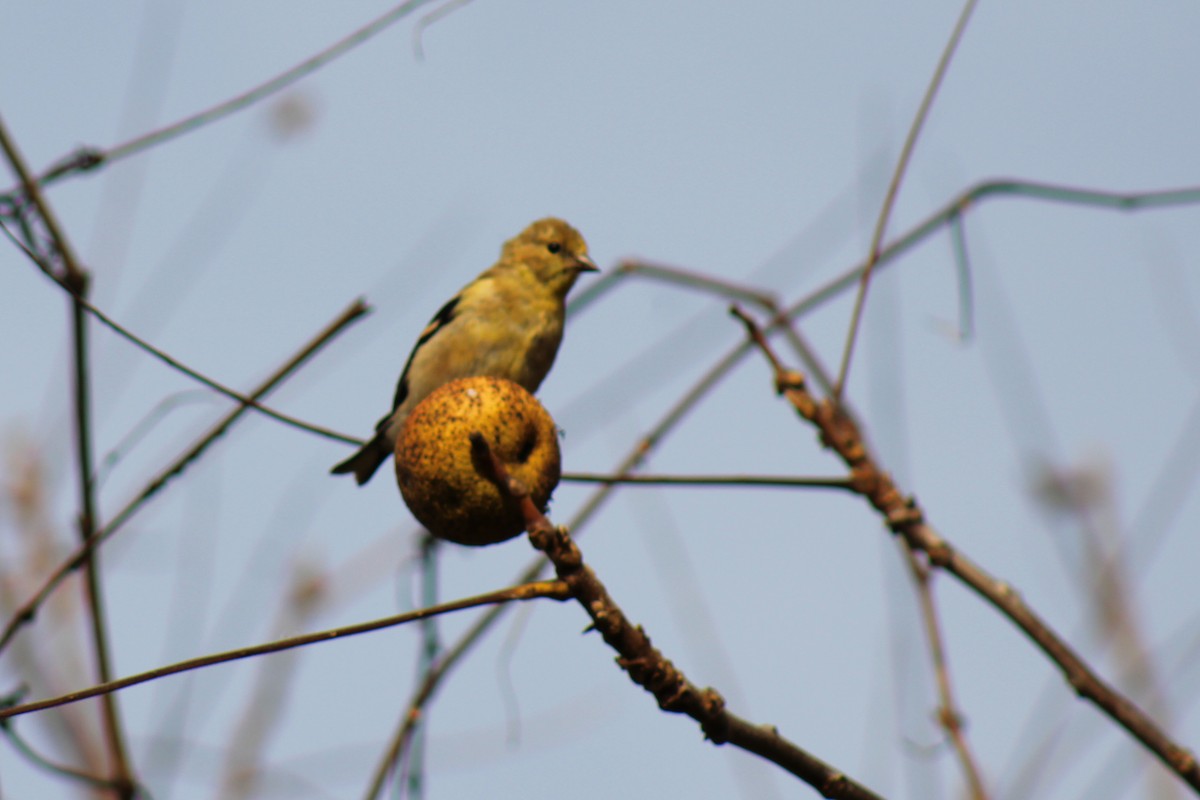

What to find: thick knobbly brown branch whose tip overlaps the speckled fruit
left=472, top=433, right=878, bottom=799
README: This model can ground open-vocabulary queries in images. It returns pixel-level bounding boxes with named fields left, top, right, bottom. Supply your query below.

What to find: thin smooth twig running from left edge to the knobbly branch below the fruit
left=0, top=581, right=571, bottom=720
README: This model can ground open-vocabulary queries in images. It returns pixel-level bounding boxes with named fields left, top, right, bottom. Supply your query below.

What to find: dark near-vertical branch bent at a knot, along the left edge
left=0, top=110, right=136, bottom=799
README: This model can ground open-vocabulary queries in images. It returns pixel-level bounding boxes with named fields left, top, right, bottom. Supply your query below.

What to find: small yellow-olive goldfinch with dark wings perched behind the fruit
left=330, top=217, right=596, bottom=486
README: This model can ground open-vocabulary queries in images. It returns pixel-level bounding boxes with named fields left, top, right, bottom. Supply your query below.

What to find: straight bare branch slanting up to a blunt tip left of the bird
left=0, top=300, right=366, bottom=651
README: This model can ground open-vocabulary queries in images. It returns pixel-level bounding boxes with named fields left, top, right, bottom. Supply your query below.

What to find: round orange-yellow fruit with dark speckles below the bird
left=396, top=378, right=562, bottom=546
